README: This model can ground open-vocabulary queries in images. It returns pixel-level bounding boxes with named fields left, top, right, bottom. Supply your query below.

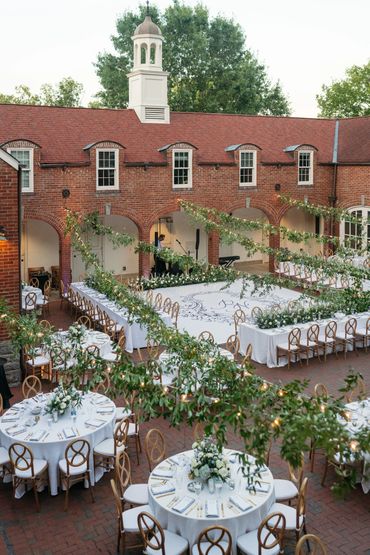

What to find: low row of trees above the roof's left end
left=0, top=77, right=83, bottom=107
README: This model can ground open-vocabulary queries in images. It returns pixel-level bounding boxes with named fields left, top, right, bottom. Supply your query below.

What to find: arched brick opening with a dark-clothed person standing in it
left=150, top=212, right=208, bottom=272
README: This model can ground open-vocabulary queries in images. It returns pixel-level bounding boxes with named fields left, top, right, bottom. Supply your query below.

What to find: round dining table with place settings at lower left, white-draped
left=0, top=393, right=116, bottom=497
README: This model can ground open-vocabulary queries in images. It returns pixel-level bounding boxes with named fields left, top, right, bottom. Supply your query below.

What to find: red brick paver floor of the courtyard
left=0, top=303, right=370, bottom=555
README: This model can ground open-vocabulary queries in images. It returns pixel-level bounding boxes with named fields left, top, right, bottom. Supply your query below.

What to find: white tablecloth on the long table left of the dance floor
left=71, top=283, right=173, bottom=353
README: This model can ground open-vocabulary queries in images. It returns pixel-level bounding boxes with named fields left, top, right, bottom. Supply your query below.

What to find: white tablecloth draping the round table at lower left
left=0, top=393, right=116, bottom=495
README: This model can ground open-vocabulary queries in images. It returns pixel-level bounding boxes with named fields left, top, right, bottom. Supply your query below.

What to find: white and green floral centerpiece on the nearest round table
left=190, top=437, right=230, bottom=482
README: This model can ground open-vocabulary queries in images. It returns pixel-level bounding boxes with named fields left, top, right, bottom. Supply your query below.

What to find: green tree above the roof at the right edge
left=316, top=62, right=370, bottom=118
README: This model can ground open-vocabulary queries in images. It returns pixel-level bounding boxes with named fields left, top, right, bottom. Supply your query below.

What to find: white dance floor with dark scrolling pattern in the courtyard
left=155, top=280, right=300, bottom=343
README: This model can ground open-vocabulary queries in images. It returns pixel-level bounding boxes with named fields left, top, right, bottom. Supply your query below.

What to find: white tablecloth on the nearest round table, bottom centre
left=149, top=450, right=275, bottom=553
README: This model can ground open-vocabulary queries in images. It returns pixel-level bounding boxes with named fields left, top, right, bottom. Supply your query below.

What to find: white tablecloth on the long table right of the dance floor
left=238, top=312, right=370, bottom=368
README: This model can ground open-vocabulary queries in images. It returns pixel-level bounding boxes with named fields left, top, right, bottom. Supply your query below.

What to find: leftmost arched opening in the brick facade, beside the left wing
left=21, top=219, right=59, bottom=287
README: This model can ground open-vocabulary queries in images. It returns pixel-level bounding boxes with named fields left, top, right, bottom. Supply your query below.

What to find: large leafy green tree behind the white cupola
left=96, top=0, right=289, bottom=115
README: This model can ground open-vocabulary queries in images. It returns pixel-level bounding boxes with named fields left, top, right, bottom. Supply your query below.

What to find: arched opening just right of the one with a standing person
left=220, top=208, right=269, bottom=272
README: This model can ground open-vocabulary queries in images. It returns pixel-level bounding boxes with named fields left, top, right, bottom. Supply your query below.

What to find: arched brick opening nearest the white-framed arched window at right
left=280, top=208, right=323, bottom=255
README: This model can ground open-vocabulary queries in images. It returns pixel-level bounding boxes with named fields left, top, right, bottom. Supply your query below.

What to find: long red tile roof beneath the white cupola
left=0, top=104, right=370, bottom=163
